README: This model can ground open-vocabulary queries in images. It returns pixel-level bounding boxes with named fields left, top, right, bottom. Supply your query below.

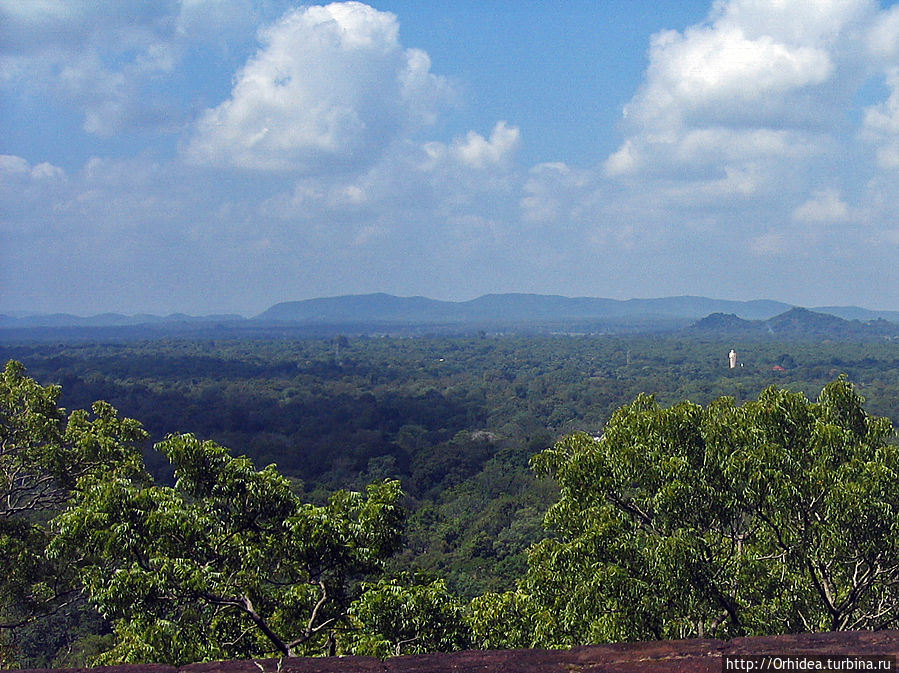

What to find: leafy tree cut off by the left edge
left=0, top=361, right=145, bottom=664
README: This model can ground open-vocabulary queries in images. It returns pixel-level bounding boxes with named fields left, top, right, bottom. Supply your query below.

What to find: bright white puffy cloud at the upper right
left=605, top=0, right=883, bottom=181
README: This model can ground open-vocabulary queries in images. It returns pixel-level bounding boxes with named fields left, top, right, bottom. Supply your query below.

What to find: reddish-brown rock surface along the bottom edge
left=12, top=631, right=899, bottom=673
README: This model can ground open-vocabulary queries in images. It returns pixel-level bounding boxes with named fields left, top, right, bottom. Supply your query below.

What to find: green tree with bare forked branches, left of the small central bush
left=51, top=435, right=403, bottom=664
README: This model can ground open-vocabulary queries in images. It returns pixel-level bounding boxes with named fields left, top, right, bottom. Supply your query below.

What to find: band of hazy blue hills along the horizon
left=0, top=293, right=899, bottom=340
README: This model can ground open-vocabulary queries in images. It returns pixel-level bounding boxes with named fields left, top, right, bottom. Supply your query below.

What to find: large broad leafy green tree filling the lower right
left=512, top=379, right=899, bottom=646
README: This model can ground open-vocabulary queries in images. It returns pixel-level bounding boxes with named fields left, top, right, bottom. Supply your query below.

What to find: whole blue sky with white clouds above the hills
left=0, top=0, right=899, bottom=316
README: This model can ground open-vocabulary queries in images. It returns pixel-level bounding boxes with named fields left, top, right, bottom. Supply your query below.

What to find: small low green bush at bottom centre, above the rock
left=347, top=579, right=469, bottom=659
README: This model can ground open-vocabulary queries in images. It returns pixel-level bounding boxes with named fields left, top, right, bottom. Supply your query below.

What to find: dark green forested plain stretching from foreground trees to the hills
left=0, top=335, right=899, bottom=664
